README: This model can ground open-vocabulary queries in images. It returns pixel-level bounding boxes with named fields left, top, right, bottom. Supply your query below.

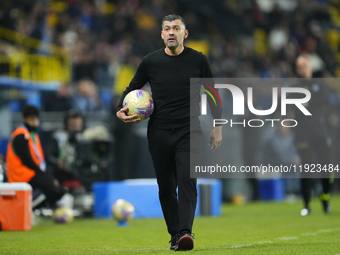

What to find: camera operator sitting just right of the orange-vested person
left=46, top=110, right=85, bottom=184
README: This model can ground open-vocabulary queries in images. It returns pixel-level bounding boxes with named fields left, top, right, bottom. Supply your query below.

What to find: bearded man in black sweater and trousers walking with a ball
left=117, top=15, right=222, bottom=250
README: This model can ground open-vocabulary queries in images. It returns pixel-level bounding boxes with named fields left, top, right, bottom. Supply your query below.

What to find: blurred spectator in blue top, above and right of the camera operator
left=73, top=79, right=105, bottom=115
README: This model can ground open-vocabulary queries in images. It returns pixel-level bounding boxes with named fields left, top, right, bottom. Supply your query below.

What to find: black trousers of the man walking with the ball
left=148, top=126, right=202, bottom=235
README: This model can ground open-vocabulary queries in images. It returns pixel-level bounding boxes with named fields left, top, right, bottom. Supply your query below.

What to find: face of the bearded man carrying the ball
left=161, top=19, right=188, bottom=49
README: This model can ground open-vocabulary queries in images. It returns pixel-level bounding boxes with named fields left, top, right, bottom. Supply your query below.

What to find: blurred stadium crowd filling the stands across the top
left=0, top=0, right=340, bottom=93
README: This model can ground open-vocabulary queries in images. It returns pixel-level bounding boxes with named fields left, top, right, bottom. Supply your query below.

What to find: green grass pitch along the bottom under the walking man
left=0, top=196, right=340, bottom=255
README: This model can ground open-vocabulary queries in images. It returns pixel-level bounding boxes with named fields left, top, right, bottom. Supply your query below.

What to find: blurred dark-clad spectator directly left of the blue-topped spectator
left=45, top=84, right=72, bottom=112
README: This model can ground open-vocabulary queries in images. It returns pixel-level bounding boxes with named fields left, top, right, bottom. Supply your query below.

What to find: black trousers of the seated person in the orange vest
left=29, top=173, right=66, bottom=208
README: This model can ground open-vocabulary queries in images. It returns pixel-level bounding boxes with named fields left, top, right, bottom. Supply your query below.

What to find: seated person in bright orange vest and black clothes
left=6, top=105, right=66, bottom=207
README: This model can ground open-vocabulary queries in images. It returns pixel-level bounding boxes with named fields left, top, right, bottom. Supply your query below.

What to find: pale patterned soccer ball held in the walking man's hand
left=123, top=89, right=153, bottom=120
